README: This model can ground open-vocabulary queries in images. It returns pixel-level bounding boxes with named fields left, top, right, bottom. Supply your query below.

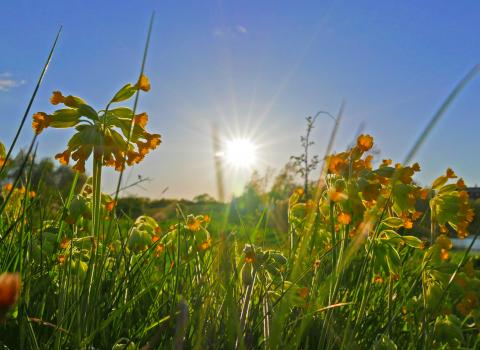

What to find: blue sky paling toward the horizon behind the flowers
left=0, top=0, right=480, bottom=198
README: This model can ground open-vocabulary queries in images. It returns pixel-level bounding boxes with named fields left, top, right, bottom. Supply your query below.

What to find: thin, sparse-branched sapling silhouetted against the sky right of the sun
left=290, top=113, right=319, bottom=196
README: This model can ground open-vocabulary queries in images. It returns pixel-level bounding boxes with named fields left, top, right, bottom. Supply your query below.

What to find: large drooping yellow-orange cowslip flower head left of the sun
left=32, top=75, right=161, bottom=173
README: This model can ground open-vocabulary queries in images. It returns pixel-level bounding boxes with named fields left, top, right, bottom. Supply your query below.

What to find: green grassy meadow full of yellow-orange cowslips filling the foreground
left=0, top=22, right=480, bottom=349
